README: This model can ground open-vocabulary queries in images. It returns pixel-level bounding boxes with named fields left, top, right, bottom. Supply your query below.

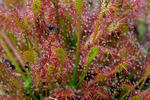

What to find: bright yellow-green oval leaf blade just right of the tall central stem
left=88, top=46, right=99, bottom=63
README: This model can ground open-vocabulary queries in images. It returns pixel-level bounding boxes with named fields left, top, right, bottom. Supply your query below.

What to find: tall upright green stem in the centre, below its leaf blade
left=73, top=16, right=81, bottom=87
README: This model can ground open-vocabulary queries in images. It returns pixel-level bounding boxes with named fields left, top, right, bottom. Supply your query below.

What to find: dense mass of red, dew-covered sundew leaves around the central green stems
left=0, top=0, right=147, bottom=100
